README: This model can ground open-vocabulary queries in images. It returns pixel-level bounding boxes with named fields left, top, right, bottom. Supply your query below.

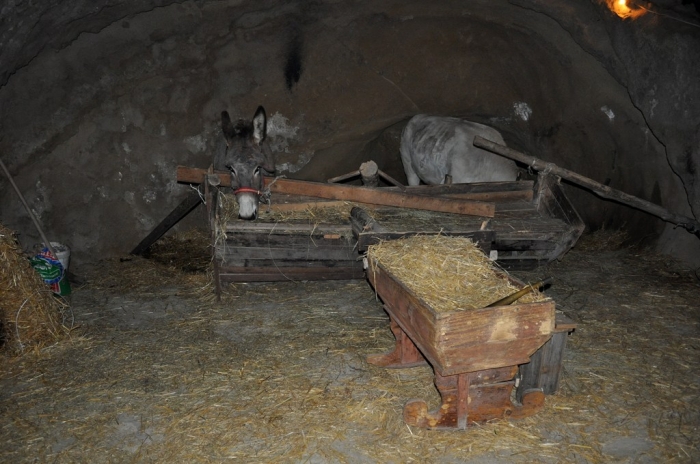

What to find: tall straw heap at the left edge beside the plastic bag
left=0, top=224, right=66, bottom=355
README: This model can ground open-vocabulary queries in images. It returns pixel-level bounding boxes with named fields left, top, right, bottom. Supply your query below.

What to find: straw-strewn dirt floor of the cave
left=0, top=236, right=700, bottom=463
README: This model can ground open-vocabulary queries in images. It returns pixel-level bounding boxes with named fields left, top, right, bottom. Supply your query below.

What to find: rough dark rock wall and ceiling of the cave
left=0, top=0, right=700, bottom=264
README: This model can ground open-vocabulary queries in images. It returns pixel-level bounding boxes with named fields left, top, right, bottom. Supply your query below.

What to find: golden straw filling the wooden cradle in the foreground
left=367, top=235, right=546, bottom=312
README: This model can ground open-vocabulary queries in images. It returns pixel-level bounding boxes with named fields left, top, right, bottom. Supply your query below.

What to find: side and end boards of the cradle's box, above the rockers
left=367, top=263, right=554, bottom=376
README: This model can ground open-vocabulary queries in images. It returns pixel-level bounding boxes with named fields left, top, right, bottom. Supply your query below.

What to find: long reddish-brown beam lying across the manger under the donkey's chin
left=177, top=166, right=496, bottom=217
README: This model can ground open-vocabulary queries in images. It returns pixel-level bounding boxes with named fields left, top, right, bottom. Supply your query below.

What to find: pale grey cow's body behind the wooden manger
left=401, top=114, right=518, bottom=185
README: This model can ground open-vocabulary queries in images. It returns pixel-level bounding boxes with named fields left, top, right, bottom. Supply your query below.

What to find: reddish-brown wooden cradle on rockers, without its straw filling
left=367, top=243, right=558, bottom=429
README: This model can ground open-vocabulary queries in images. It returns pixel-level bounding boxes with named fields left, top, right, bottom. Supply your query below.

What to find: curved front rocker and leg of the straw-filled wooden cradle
left=403, top=366, right=544, bottom=430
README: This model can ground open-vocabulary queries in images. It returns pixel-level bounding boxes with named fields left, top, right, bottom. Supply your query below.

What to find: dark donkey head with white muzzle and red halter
left=221, top=106, right=275, bottom=219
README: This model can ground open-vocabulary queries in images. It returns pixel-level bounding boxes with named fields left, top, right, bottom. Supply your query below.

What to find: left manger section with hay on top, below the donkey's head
left=209, top=190, right=364, bottom=282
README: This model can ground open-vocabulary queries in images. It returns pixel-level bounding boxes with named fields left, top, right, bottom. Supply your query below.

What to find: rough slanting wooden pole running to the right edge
left=474, top=135, right=700, bottom=238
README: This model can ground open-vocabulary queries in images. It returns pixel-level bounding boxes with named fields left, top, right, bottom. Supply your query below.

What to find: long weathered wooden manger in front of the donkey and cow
left=177, top=167, right=584, bottom=291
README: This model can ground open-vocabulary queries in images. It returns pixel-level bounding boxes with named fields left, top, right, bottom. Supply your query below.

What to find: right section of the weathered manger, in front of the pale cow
left=352, top=174, right=585, bottom=269
